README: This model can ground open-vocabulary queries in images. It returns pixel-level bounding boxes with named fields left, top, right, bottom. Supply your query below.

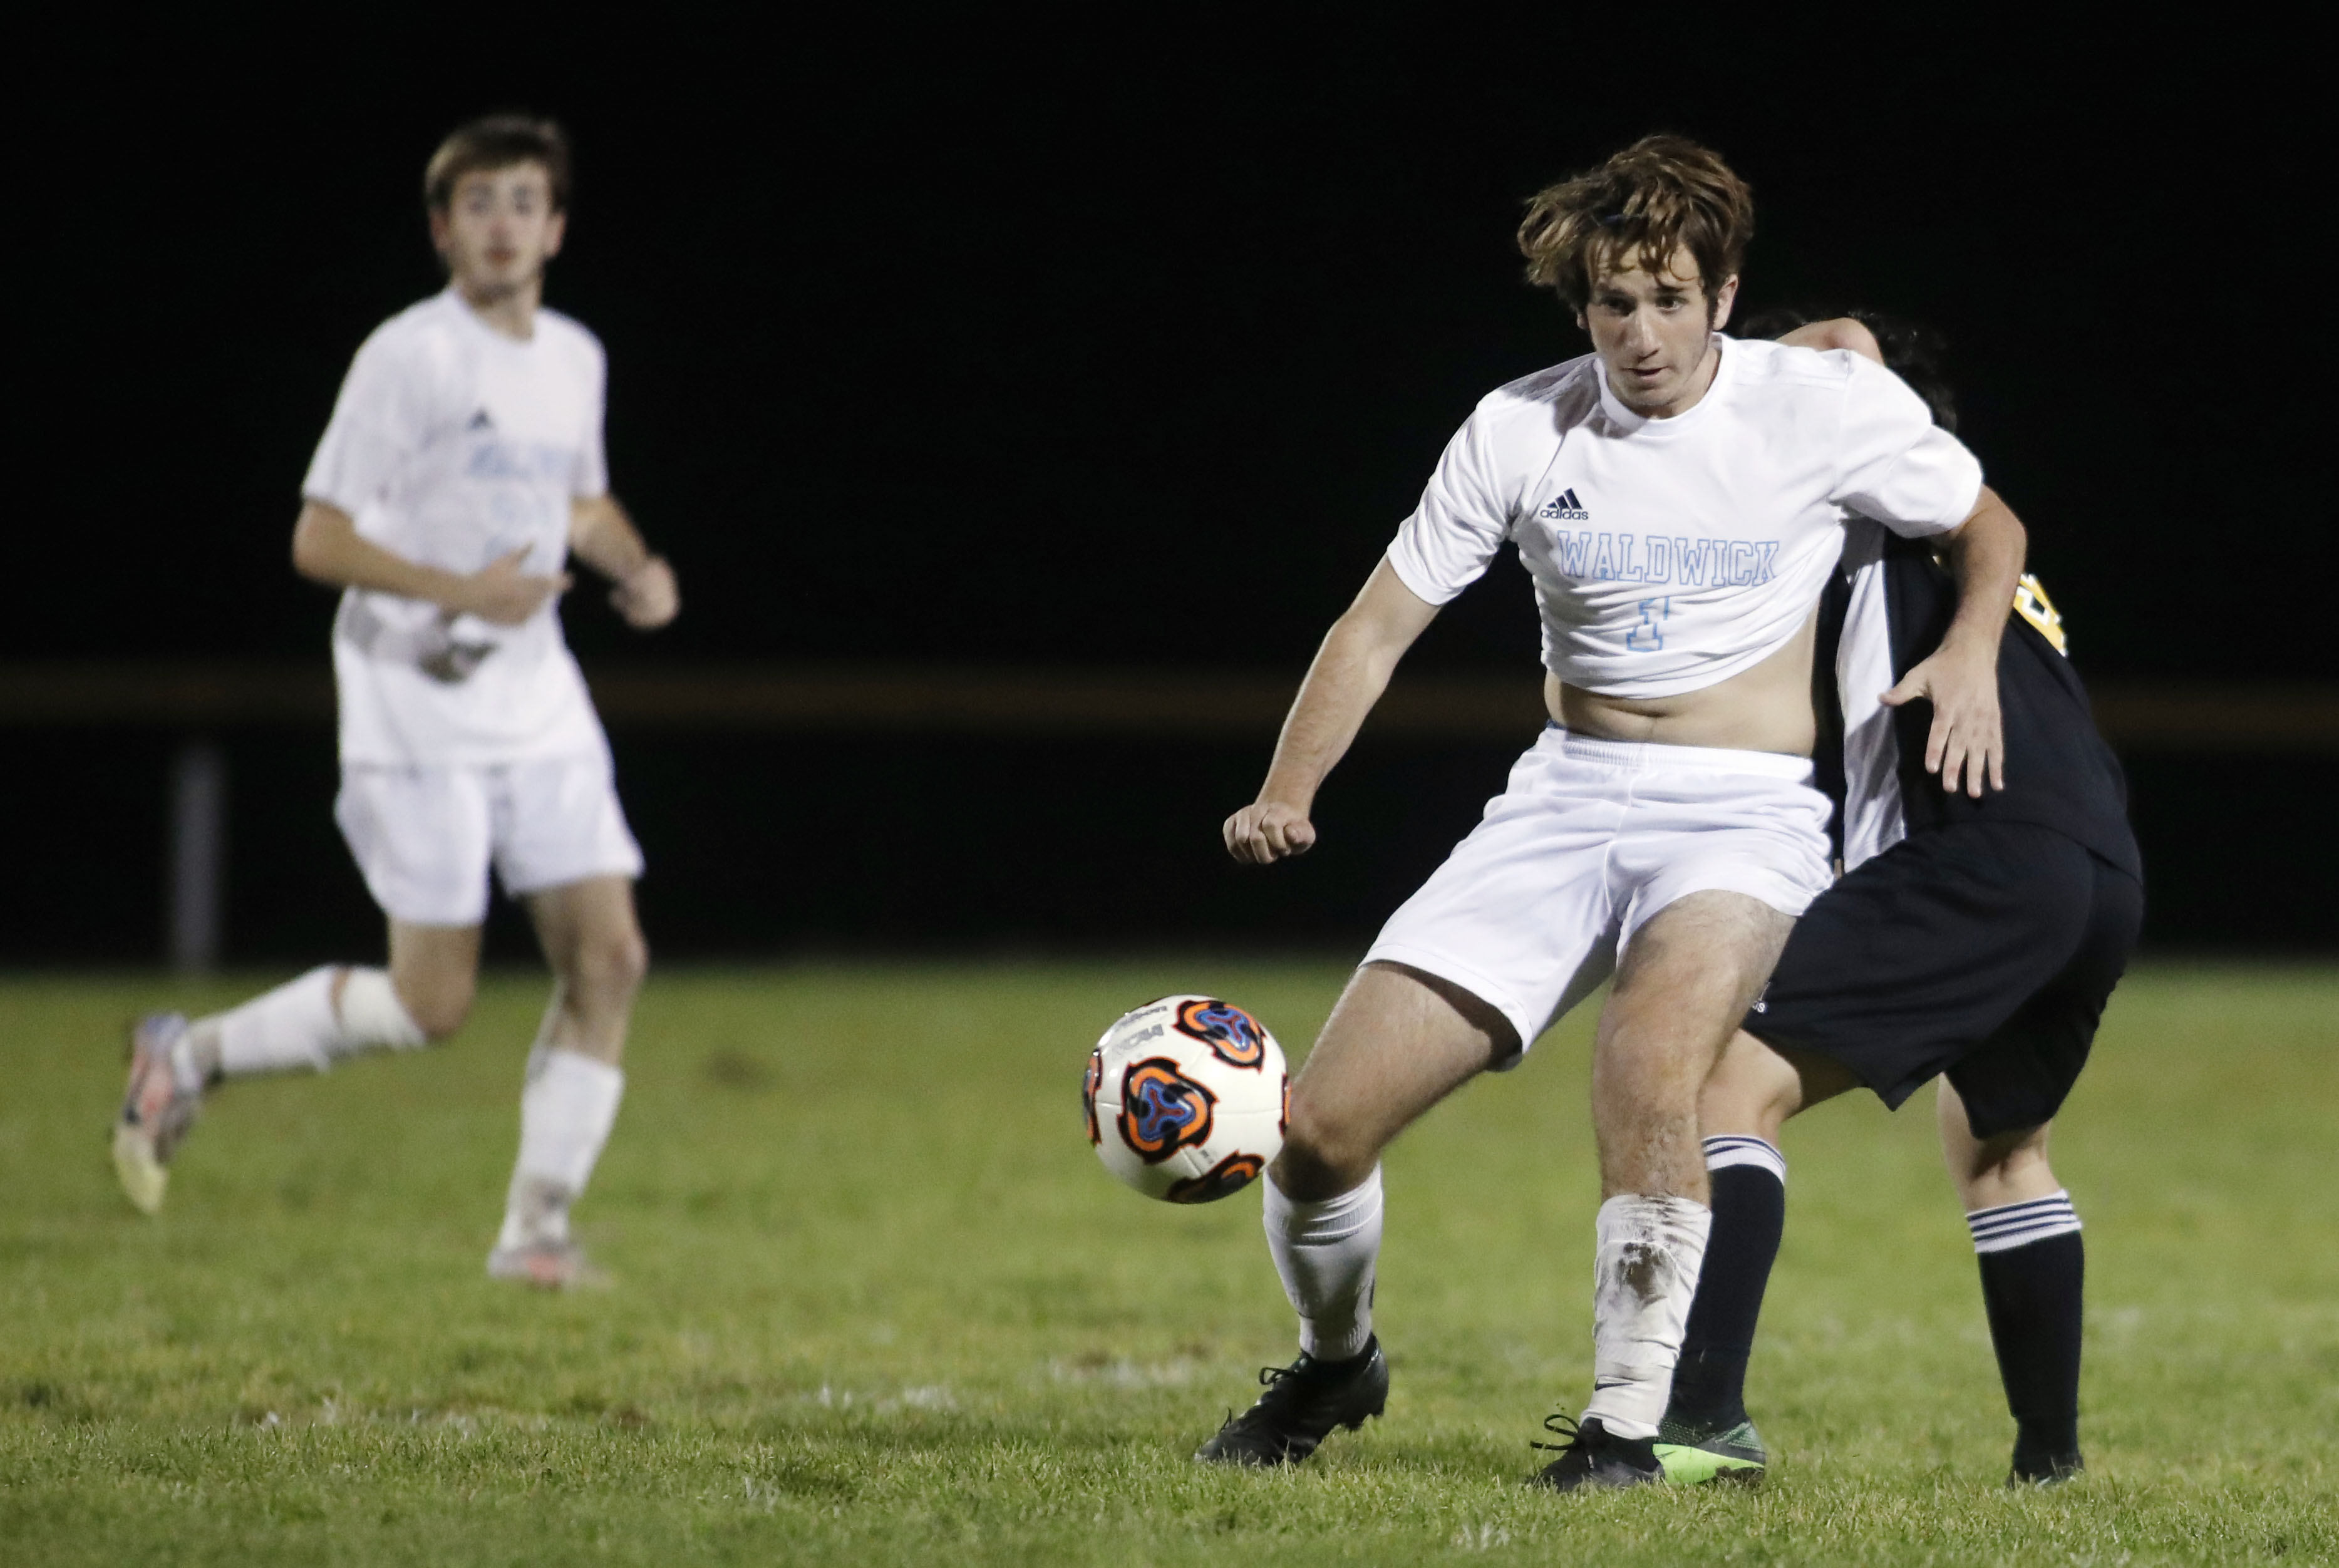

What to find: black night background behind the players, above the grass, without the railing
left=0, top=7, right=2339, bottom=962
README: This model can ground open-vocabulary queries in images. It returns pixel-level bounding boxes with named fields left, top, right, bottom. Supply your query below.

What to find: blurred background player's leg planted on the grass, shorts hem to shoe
left=487, top=877, right=650, bottom=1289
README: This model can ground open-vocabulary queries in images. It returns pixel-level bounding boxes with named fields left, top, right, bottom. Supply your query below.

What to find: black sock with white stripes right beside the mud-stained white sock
left=1665, top=1135, right=1787, bottom=1432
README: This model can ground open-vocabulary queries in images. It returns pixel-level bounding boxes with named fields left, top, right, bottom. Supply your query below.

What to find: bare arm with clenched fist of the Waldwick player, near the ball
left=1226, top=559, right=1438, bottom=866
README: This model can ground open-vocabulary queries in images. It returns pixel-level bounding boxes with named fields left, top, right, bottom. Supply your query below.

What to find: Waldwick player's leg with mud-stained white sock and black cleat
left=1534, top=892, right=1794, bottom=1491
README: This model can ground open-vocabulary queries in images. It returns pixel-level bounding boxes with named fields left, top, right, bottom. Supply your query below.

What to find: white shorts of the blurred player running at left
left=332, top=756, right=641, bottom=924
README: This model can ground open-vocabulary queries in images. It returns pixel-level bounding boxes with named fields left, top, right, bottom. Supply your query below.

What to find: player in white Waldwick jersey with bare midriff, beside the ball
left=1197, top=138, right=2023, bottom=1491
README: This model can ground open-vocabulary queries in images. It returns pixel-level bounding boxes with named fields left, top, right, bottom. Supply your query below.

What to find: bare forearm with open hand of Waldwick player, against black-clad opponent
left=1883, top=485, right=2030, bottom=800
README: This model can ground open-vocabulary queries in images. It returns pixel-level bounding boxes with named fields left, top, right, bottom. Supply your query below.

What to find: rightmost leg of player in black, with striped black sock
left=1937, top=1079, right=2087, bottom=1486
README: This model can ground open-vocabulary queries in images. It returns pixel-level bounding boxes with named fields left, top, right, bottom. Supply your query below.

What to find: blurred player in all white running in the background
left=115, top=115, right=678, bottom=1287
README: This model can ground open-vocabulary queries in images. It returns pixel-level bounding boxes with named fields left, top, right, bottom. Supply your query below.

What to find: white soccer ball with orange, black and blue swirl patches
left=1081, top=997, right=1291, bottom=1203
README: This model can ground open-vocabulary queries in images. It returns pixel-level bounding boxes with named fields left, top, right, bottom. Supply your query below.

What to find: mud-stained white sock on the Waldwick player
left=1584, top=1194, right=1715, bottom=1437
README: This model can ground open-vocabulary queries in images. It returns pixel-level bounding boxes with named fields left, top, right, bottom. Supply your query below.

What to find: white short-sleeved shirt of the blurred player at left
left=302, top=290, right=608, bottom=765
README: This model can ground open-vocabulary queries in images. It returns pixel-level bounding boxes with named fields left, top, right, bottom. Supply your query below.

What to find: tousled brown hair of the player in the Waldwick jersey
left=1518, top=136, right=1754, bottom=311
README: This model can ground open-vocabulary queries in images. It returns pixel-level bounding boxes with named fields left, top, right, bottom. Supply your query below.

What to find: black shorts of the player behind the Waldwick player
left=1745, top=822, right=2145, bottom=1137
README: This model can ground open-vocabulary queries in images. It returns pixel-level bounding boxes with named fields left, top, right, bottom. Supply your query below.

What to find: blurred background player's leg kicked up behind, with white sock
left=115, top=945, right=451, bottom=1215
